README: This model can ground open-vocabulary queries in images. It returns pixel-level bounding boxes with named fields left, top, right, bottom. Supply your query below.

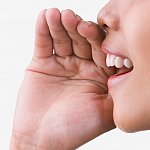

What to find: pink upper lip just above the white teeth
left=101, top=42, right=128, bottom=59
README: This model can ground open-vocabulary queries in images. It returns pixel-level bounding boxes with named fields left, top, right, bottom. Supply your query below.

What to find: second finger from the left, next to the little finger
left=46, top=8, right=72, bottom=57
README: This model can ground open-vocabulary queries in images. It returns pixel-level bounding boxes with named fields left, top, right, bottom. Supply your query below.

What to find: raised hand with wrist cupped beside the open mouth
left=11, top=8, right=115, bottom=150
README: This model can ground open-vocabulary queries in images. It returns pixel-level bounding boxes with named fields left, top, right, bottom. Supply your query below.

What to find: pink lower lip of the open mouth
left=108, top=71, right=131, bottom=89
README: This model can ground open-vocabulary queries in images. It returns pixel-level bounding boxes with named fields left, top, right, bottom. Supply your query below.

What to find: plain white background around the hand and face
left=0, top=0, right=150, bottom=150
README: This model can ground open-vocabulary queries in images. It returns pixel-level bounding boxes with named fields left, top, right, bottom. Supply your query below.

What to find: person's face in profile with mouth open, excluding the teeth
left=98, top=0, right=150, bottom=132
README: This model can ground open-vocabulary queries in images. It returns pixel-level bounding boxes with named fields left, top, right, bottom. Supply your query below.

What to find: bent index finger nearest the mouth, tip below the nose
left=77, top=21, right=115, bottom=76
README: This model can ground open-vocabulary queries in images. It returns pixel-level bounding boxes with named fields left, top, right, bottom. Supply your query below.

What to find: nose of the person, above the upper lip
left=97, top=2, right=119, bottom=31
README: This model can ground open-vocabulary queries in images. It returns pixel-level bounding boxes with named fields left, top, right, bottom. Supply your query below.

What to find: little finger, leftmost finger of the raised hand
left=34, top=10, right=53, bottom=58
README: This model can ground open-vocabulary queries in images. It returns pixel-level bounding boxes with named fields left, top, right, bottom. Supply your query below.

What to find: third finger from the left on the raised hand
left=61, top=10, right=92, bottom=59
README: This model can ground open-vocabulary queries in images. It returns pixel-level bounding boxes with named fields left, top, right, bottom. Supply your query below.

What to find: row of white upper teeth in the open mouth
left=106, top=54, right=133, bottom=68
